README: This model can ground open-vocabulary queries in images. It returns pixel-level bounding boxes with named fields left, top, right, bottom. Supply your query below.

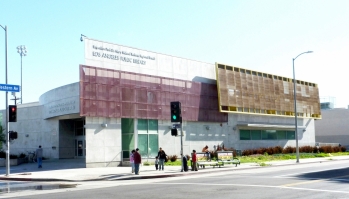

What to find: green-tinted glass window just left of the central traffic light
left=137, top=119, right=159, bottom=158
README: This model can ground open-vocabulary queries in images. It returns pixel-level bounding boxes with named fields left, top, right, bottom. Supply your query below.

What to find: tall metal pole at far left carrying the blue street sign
left=0, top=25, right=10, bottom=176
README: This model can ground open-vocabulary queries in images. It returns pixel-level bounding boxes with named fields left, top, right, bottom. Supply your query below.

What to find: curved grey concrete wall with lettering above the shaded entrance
left=39, top=82, right=80, bottom=119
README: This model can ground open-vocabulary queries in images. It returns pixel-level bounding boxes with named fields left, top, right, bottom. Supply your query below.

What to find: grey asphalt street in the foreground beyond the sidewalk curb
left=0, top=161, right=349, bottom=199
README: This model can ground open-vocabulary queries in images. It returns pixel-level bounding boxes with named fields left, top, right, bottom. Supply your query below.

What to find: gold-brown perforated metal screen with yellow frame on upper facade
left=216, top=63, right=321, bottom=119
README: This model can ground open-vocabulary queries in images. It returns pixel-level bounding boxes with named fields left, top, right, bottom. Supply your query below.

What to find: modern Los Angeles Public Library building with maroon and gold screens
left=2, top=38, right=321, bottom=167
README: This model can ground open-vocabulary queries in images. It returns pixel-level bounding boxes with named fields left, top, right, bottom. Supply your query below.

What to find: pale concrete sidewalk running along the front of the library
left=0, top=156, right=349, bottom=182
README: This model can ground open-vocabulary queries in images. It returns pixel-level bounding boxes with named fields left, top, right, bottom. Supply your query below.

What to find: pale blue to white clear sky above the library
left=0, top=0, right=349, bottom=109
